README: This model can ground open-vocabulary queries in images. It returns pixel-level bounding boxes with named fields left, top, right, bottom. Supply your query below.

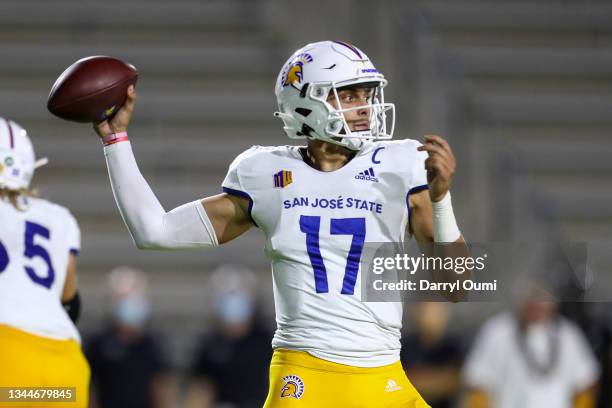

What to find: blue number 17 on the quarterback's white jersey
left=300, top=215, right=365, bottom=295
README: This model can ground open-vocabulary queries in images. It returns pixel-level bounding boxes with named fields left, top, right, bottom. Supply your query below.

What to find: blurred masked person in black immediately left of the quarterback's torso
left=186, top=266, right=272, bottom=408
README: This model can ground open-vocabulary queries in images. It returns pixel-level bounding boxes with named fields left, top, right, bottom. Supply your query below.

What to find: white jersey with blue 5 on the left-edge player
left=0, top=199, right=81, bottom=341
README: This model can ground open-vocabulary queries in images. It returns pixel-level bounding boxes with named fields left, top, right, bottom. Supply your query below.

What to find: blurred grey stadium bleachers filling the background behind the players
left=0, top=0, right=612, bottom=406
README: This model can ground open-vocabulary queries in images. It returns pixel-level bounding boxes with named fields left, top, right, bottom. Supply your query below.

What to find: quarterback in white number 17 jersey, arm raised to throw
left=95, top=41, right=463, bottom=407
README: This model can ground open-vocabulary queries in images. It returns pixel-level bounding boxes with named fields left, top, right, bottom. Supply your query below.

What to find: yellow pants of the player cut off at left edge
left=0, top=325, right=90, bottom=408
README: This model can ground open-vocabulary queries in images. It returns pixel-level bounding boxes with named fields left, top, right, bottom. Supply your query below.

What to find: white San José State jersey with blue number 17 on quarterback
left=223, top=140, right=427, bottom=367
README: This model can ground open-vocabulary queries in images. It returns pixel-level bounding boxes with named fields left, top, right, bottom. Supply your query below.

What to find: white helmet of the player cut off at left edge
left=0, top=117, right=47, bottom=190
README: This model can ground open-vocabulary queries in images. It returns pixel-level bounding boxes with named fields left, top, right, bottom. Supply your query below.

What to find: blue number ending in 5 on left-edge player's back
left=0, top=221, right=55, bottom=289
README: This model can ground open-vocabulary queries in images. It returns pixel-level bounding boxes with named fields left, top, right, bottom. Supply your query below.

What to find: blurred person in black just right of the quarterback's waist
left=401, top=302, right=463, bottom=408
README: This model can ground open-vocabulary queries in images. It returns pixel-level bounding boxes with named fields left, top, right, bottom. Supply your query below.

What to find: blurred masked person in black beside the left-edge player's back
left=86, top=267, right=174, bottom=408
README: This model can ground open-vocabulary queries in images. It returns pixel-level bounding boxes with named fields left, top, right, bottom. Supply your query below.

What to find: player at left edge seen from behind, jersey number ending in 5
left=0, top=118, right=89, bottom=407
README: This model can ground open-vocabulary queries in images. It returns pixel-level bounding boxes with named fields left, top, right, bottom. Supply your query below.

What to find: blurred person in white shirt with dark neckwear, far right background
left=464, top=287, right=598, bottom=408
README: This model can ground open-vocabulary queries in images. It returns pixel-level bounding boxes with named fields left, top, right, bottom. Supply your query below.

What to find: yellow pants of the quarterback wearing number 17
left=264, top=349, right=429, bottom=408
